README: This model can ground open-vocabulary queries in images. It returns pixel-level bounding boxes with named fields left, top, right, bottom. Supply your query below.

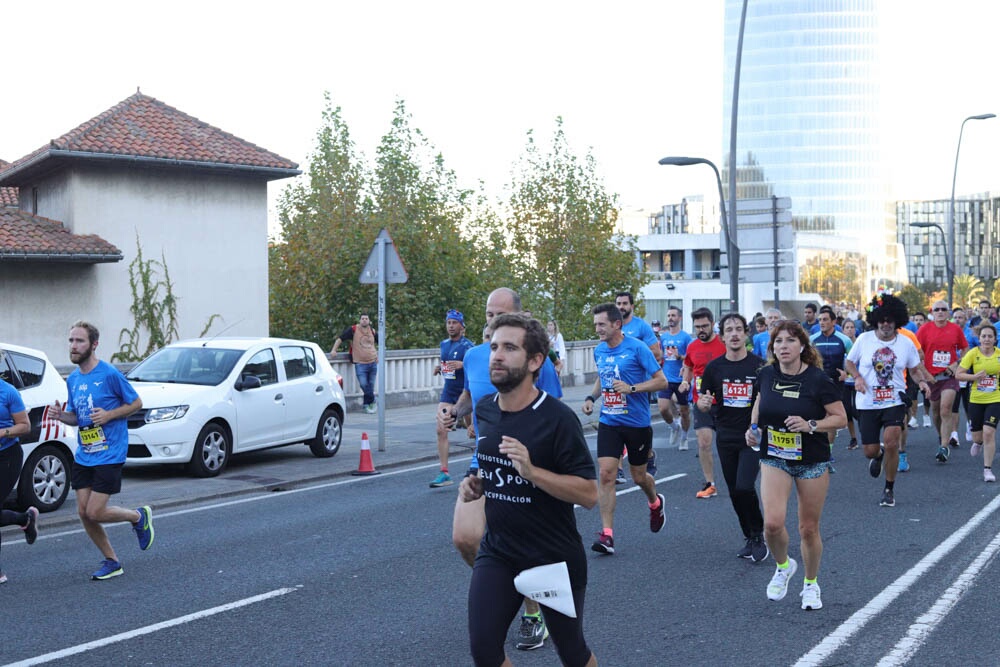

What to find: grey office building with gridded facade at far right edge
left=896, top=193, right=1000, bottom=286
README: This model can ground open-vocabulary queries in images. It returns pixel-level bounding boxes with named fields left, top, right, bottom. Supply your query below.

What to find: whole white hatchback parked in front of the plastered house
left=126, top=338, right=346, bottom=477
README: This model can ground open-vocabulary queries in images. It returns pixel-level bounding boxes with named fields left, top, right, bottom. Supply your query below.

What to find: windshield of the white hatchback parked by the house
left=125, top=347, right=244, bottom=386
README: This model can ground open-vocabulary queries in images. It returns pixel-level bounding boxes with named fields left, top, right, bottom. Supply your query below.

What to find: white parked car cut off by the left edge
left=0, top=343, right=77, bottom=512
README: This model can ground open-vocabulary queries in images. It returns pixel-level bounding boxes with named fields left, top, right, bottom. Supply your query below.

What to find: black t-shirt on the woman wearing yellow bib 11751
left=757, top=364, right=842, bottom=465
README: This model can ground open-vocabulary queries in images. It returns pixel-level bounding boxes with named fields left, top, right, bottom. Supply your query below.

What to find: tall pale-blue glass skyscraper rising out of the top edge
left=720, top=0, right=898, bottom=282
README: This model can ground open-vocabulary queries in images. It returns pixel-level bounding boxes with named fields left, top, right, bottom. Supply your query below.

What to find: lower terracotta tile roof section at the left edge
left=0, top=208, right=122, bottom=261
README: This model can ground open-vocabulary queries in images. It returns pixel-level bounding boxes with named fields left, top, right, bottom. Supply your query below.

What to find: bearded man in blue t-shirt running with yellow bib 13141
left=49, top=322, right=154, bottom=580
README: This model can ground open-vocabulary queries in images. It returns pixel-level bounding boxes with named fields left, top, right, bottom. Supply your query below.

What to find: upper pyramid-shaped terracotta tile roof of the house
left=0, top=92, right=298, bottom=183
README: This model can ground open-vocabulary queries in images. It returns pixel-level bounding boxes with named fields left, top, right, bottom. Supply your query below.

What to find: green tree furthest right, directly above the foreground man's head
left=504, top=118, right=648, bottom=339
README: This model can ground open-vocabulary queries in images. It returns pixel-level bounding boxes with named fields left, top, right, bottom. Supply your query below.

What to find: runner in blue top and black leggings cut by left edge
left=0, top=370, right=38, bottom=584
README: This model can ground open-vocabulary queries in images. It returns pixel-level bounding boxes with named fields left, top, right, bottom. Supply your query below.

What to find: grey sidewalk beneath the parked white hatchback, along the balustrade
left=3, top=384, right=596, bottom=539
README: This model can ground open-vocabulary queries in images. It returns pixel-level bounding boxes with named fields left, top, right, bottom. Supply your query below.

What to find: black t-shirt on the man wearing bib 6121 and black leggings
left=701, top=354, right=766, bottom=447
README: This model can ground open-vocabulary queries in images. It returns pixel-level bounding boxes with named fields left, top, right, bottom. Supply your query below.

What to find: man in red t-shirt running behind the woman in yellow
left=917, top=301, right=968, bottom=463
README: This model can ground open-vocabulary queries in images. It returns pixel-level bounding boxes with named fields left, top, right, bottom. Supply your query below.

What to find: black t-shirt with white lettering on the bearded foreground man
left=476, top=392, right=597, bottom=588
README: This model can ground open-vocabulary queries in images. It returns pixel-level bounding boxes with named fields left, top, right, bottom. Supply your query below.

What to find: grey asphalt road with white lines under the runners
left=0, top=418, right=1000, bottom=666
